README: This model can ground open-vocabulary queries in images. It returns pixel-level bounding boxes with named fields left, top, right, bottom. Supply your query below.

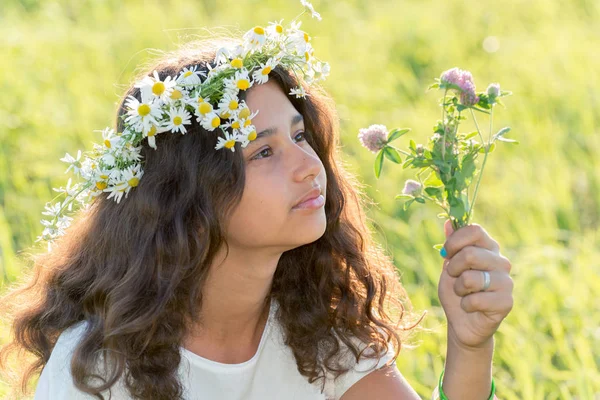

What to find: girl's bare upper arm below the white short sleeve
left=340, top=364, right=421, bottom=400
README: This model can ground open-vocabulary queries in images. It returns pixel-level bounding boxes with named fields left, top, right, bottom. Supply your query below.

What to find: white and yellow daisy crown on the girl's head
left=36, top=0, right=329, bottom=251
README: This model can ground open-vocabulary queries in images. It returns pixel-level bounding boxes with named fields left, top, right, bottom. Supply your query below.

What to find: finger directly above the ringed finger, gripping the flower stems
left=446, top=246, right=511, bottom=278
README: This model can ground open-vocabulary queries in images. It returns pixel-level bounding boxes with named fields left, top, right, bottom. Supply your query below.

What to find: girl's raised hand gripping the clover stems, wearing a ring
left=438, top=220, right=513, bottom=349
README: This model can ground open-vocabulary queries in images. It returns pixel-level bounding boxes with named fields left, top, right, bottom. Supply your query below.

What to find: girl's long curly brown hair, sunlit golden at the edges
left=0, top=38, right=424, bottom=400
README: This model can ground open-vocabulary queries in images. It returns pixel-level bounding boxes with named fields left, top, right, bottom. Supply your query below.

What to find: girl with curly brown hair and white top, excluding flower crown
left=1, top=21, right=512, bottom=400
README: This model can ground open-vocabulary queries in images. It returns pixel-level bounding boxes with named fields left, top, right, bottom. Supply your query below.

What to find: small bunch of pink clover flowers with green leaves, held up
left=358, top=68, right=519, bottom=250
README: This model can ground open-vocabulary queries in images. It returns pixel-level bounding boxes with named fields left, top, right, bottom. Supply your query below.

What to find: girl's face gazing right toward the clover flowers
left=227, top=81, right=327, bottom=254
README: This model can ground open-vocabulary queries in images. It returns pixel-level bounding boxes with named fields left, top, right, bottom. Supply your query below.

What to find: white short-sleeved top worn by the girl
left=34, top=299, right=394, bottom=400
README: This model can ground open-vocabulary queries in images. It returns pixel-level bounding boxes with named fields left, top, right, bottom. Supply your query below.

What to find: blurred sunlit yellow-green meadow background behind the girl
left=0, top=0, right=600, bottom=400
